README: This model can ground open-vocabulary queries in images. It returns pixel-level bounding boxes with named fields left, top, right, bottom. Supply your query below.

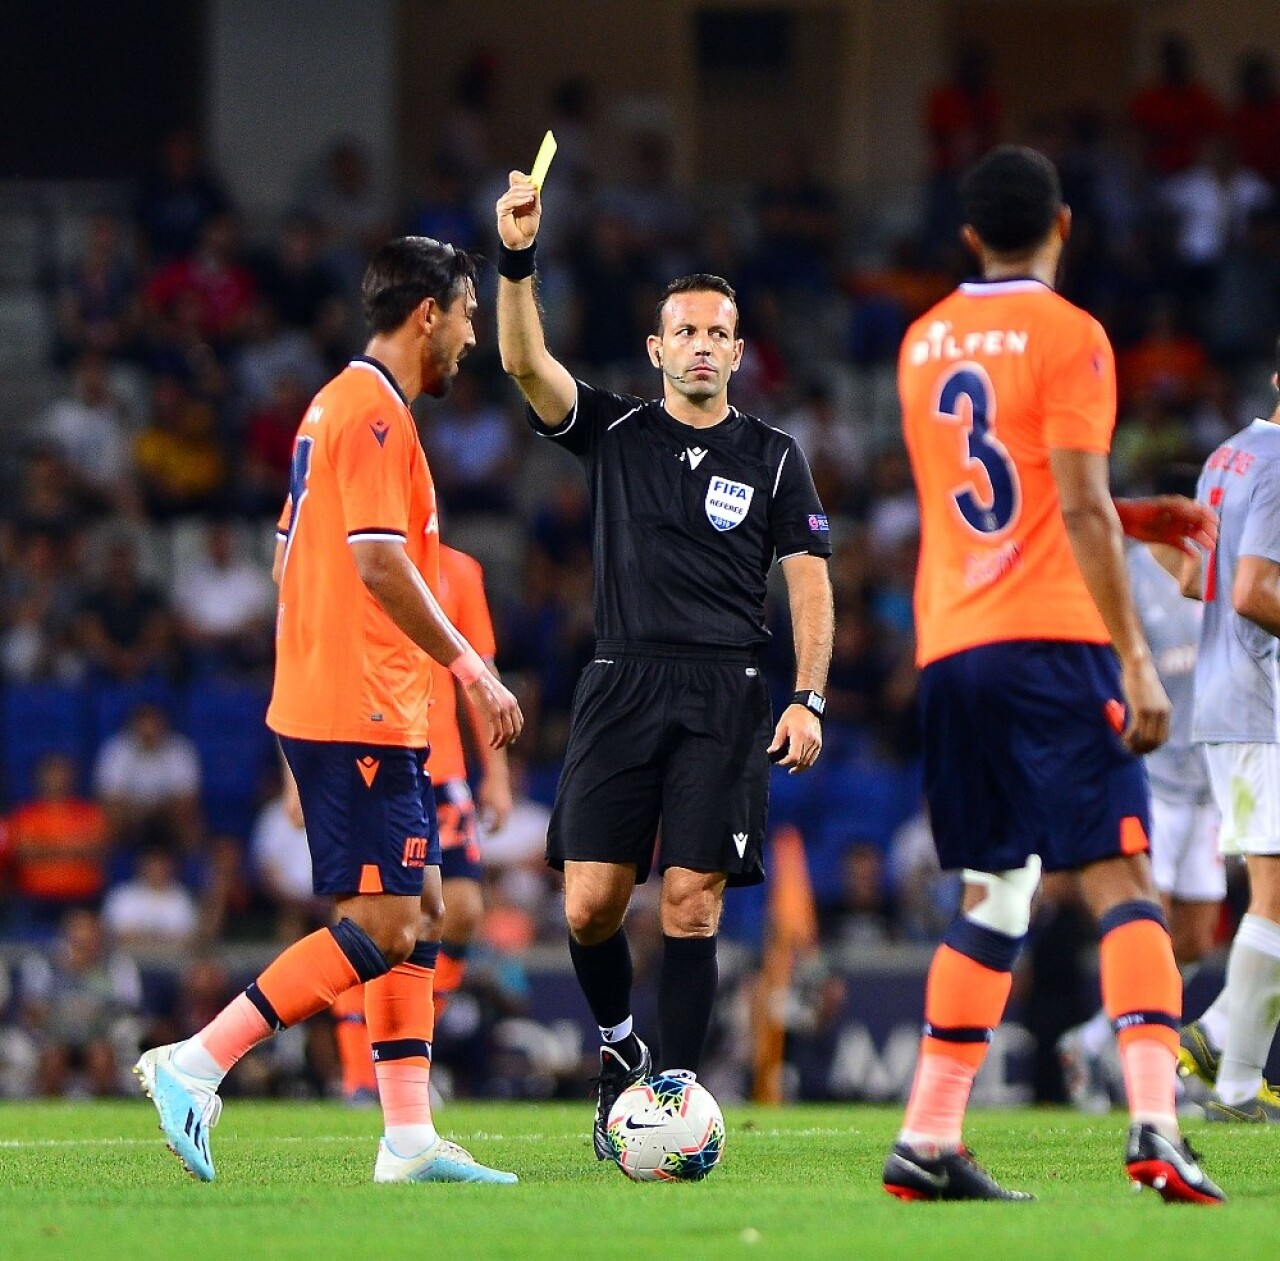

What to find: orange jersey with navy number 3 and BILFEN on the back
left=899, top=280, right=1116, bottom=666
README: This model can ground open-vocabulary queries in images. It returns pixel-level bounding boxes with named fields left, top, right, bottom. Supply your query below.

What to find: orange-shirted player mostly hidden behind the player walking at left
left=333, top=544, right=511, bottom=1100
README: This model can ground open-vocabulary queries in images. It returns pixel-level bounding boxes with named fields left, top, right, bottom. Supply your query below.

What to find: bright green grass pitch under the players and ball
left=0, top=1100, right=1280, bottom=1261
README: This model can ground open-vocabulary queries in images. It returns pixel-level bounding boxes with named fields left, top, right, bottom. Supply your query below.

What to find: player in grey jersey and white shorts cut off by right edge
left=1162, top=358, right=1280, bottom=1121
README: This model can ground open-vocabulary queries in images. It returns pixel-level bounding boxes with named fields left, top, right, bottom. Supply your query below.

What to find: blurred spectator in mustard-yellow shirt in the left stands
left=134, top=374, right=227, bottom=520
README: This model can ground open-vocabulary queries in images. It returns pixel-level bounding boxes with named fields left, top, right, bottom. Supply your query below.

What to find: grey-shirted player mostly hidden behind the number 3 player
left=1057, top=544, right=1226, bottom=1112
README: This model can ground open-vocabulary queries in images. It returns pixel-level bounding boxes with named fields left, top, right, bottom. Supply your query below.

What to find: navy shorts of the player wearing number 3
left=920, top=640, right=1151, bottom=872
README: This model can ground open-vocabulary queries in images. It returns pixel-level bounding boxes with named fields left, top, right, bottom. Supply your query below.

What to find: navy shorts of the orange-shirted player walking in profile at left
left=280, top=736, right=440, bottom=897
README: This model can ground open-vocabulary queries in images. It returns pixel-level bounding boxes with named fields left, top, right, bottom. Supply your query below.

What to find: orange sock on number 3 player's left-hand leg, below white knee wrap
left=899, top=919, right=1019, bottom=1151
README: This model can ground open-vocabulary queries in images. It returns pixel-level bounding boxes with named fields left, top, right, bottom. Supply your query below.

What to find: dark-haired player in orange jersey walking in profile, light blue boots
left=137, top=237, right=524, bottom=1183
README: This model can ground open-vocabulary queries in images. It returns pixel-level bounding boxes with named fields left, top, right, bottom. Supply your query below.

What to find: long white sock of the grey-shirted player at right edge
left=1217, top=915, right=1280, bottom=1104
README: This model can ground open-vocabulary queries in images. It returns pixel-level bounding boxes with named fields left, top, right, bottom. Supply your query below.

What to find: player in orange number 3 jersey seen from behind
left=883, top=147, right=1224, bottom=1203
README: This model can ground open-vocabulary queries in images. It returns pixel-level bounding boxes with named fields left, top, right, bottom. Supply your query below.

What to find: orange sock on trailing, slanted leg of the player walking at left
left=174, top=919, right=387, bottom=1080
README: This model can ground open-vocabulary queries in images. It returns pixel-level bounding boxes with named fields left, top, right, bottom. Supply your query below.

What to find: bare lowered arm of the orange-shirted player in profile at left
left=351, top=539, right=525, bottom=749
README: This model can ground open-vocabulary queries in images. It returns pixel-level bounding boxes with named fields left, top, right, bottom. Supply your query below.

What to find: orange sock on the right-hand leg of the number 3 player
left=1098, top=901, right=1183, bottom=1130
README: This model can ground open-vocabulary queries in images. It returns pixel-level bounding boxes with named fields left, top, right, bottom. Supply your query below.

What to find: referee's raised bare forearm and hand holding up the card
left=497, top=170, right=577, bottom=429
